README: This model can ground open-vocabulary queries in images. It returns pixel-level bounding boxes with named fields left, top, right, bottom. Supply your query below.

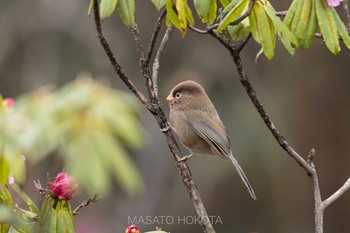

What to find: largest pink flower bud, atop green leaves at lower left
left=49, top=172, right=78, bottom=200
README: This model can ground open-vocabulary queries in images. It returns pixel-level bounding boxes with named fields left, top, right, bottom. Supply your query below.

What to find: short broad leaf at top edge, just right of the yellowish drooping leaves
left=193, top=0, right=217, bottom=25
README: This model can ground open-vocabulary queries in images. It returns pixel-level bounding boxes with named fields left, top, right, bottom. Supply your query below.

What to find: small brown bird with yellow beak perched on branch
left=167, top=80, right=256, bottom=200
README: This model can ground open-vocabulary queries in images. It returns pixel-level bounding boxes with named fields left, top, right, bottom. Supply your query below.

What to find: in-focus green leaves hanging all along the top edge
left=90, top=0, right=350, bottom=59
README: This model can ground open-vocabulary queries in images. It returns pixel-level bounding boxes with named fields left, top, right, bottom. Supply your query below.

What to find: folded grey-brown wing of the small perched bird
left=183, top=110, right=231, bottom=159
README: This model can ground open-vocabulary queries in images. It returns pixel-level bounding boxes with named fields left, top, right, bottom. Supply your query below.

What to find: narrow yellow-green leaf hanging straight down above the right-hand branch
left=256, top=4, right=276, bottom=59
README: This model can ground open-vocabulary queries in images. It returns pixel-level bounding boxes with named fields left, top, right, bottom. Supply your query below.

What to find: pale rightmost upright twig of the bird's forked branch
left=152, top=24, right=174, bottom=98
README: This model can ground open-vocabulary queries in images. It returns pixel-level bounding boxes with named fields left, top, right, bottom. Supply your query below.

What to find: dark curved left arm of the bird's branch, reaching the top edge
left=94, top=0, right=154, bottom=112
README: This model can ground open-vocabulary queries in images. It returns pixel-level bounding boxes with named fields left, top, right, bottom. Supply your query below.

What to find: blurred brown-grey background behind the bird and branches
left=0, top=0, right=350, bottom=233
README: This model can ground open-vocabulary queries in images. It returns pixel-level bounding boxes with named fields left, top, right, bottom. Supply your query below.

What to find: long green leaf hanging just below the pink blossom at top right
left=316, top=0, right=340, bottom=54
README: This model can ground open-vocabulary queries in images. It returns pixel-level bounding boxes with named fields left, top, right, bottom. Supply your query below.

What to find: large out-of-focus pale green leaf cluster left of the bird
left=0, top=75, right=143, bottom=194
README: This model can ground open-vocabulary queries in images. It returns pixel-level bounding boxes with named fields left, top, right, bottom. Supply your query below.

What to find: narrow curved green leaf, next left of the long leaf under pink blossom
left=299, top=0, right=317, bottom=50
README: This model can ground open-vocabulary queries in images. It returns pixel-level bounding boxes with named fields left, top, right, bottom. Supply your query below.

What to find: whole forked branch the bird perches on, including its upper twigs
left=93, top=0, right=215, bottom=233
